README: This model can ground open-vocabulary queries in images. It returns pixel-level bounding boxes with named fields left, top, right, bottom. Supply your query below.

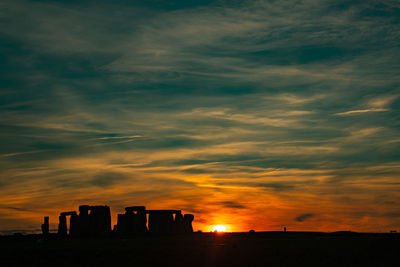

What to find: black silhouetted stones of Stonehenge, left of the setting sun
left=53, top=205, right=194, bottom=237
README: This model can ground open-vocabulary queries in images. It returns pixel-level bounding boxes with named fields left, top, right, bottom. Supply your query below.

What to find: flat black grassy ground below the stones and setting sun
left=0, top=232, right=400, bottom=267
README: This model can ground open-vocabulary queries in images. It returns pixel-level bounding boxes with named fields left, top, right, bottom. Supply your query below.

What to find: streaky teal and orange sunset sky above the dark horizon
left=0, top=0, right=400, bottom=233
